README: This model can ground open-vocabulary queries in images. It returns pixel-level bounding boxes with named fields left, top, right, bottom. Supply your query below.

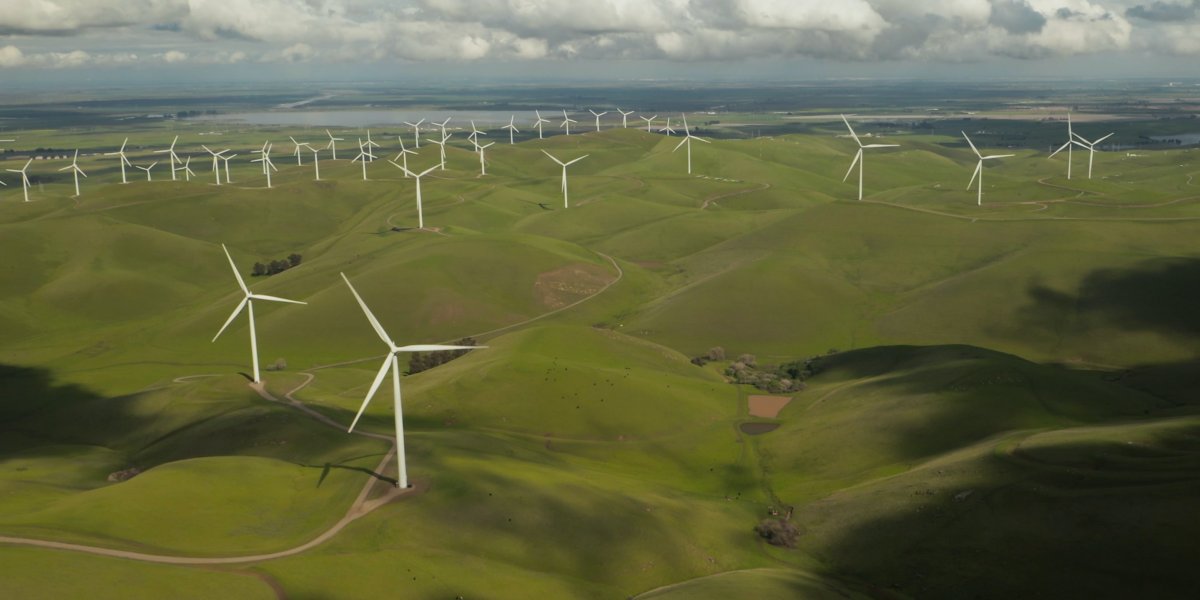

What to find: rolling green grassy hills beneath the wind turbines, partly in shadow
left=0, top=85, right=1200, bottom=599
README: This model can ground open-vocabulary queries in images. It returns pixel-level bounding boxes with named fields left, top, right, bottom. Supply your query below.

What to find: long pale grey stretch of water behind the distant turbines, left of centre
left=190, top=110, right=544, bottom=131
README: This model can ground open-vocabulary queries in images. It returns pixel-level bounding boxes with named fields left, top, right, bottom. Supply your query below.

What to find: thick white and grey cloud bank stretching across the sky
left=0, top=0, right=1200, bottom=68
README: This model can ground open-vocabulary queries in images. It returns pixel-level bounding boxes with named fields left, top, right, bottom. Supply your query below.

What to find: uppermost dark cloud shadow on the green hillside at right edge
left=1019, top=258, right=1200, bottom=341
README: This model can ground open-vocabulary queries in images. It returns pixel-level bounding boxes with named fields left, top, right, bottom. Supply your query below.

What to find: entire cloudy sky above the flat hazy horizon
left=0, top=0, right=1200, bottom=86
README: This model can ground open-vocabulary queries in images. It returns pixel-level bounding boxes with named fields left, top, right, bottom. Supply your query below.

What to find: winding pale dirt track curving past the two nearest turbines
left=0, top=254, right=625, bottom=566
